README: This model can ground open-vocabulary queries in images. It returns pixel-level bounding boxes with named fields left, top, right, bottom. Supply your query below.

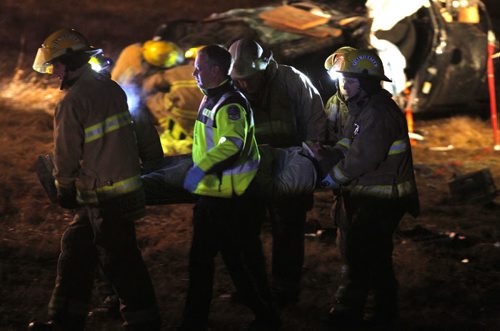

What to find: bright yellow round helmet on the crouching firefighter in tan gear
left=142, top=40, right=184, bottom=69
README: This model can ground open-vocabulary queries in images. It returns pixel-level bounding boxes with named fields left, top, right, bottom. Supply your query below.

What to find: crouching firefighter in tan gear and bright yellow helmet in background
left=111, top=26, right=202, bottom=155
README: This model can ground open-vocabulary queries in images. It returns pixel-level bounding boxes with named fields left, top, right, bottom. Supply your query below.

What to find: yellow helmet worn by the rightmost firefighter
left=337, top=49, right=391, bottom=82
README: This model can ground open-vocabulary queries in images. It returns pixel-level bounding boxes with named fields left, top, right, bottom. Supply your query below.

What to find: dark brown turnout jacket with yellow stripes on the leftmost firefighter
left=54, top=66, right=150, bottom=218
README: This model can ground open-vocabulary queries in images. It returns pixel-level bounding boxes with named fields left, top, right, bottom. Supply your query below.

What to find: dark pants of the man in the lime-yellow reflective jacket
left=183, top=196, right=273, bottom=330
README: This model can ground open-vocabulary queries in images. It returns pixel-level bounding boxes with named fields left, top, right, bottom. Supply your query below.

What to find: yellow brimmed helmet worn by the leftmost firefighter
left=33, top=29, right=102, bottom=74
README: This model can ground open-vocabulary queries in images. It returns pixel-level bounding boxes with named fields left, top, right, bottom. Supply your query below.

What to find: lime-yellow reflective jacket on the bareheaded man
left=192, top=79, right=260, bottom=198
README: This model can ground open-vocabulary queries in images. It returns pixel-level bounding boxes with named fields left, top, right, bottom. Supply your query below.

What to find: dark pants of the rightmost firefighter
left=336, top=195, right=405, bottom=318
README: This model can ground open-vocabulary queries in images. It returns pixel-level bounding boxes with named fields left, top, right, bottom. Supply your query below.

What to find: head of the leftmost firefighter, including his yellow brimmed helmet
left=33, top=29, right=102, bottom=78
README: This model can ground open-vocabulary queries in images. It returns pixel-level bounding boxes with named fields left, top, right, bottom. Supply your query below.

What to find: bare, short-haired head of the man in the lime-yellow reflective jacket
left=193, top=45, right=232, bottom=89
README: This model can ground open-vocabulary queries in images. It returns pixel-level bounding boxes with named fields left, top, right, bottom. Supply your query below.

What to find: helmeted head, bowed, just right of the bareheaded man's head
left=229, top=39, right=272, bottom=94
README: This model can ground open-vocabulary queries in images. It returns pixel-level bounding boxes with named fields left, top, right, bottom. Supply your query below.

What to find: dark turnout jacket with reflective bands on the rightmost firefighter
left=330, top=90, right=418, bottom=218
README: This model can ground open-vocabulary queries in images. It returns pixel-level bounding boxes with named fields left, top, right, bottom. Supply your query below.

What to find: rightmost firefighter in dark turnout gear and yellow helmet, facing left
left=315, top=50, right=419, bottom=330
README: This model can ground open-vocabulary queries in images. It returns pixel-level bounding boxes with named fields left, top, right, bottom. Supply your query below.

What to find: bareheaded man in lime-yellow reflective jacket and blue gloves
left=181, top=45, right=279, bottom=330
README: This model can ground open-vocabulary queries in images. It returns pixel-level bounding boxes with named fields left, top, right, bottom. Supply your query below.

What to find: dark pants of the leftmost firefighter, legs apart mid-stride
left=49, top=207, right=160, bottom=329
